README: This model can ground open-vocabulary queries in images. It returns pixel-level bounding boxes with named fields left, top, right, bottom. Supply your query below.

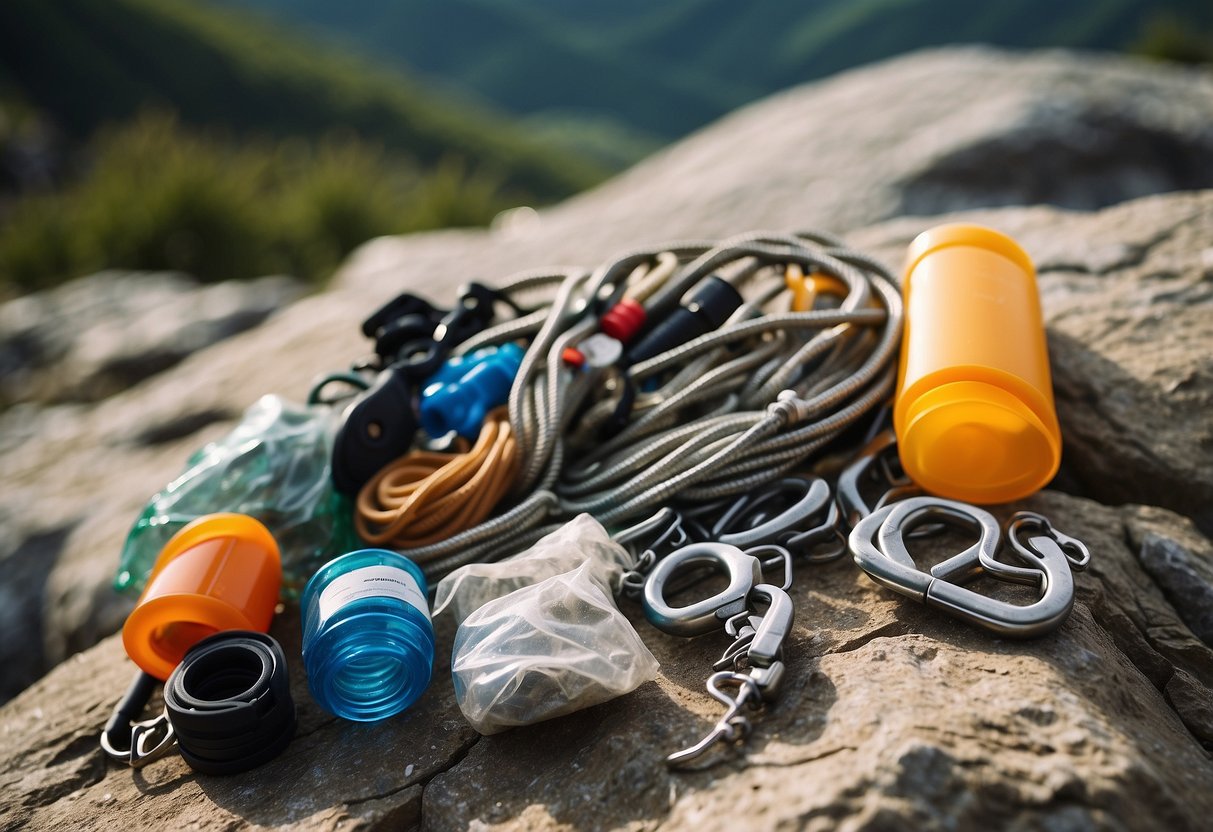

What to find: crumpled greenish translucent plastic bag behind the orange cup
left=114, top=395, right=361, bottom=599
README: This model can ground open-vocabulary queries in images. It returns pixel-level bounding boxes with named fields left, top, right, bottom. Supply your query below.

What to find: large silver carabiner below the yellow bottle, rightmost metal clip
left=849, top=497, right=1089, bottom=638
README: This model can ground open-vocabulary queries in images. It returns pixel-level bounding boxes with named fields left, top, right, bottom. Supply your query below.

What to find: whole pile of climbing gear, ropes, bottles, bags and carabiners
left=102, top=224, right=1090, bottom=774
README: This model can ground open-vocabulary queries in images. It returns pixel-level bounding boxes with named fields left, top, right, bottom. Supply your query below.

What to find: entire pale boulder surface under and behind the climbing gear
left=0, top=50, right=1213, bottom=830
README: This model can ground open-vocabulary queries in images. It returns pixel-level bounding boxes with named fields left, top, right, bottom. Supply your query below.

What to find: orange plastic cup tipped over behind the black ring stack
left=123, top=514, right=283, bottom=680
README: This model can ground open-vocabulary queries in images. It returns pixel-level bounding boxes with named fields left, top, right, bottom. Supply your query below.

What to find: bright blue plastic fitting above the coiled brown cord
left=421, top=343, right=523, bottom=440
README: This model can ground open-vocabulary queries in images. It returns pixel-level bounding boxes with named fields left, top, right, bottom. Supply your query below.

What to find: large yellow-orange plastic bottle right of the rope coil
left=893, top=223, right=1061, bottom=503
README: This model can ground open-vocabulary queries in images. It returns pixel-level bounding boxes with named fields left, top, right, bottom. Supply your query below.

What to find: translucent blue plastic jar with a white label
left=303, top=549, right=434, bottom=722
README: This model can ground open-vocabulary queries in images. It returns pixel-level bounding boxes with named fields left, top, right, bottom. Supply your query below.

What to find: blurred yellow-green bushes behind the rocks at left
left=0, top=114, right=508, bottom=297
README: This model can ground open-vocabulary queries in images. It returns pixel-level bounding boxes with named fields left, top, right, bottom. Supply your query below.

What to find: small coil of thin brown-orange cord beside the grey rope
left=354, top=408, right=518, bottom=549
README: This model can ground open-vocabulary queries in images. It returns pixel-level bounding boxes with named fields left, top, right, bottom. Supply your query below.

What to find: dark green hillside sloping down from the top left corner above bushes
left=0, top=0, right=600, bottom=200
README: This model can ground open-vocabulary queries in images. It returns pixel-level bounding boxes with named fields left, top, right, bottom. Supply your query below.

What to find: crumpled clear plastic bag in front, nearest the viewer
left=451, top=563, right=659, bottom=734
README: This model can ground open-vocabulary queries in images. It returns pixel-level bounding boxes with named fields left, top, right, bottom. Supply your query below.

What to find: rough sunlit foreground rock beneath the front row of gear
left=0, top=494, right=1213, bottom=830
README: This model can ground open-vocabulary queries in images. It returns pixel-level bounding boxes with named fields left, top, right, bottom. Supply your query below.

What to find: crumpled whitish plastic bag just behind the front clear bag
left=434, top=514, right=632, bottom=623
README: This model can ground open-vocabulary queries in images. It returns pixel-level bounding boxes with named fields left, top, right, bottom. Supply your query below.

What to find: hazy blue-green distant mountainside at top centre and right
left=212, top=0, right=1213, bottom=139
